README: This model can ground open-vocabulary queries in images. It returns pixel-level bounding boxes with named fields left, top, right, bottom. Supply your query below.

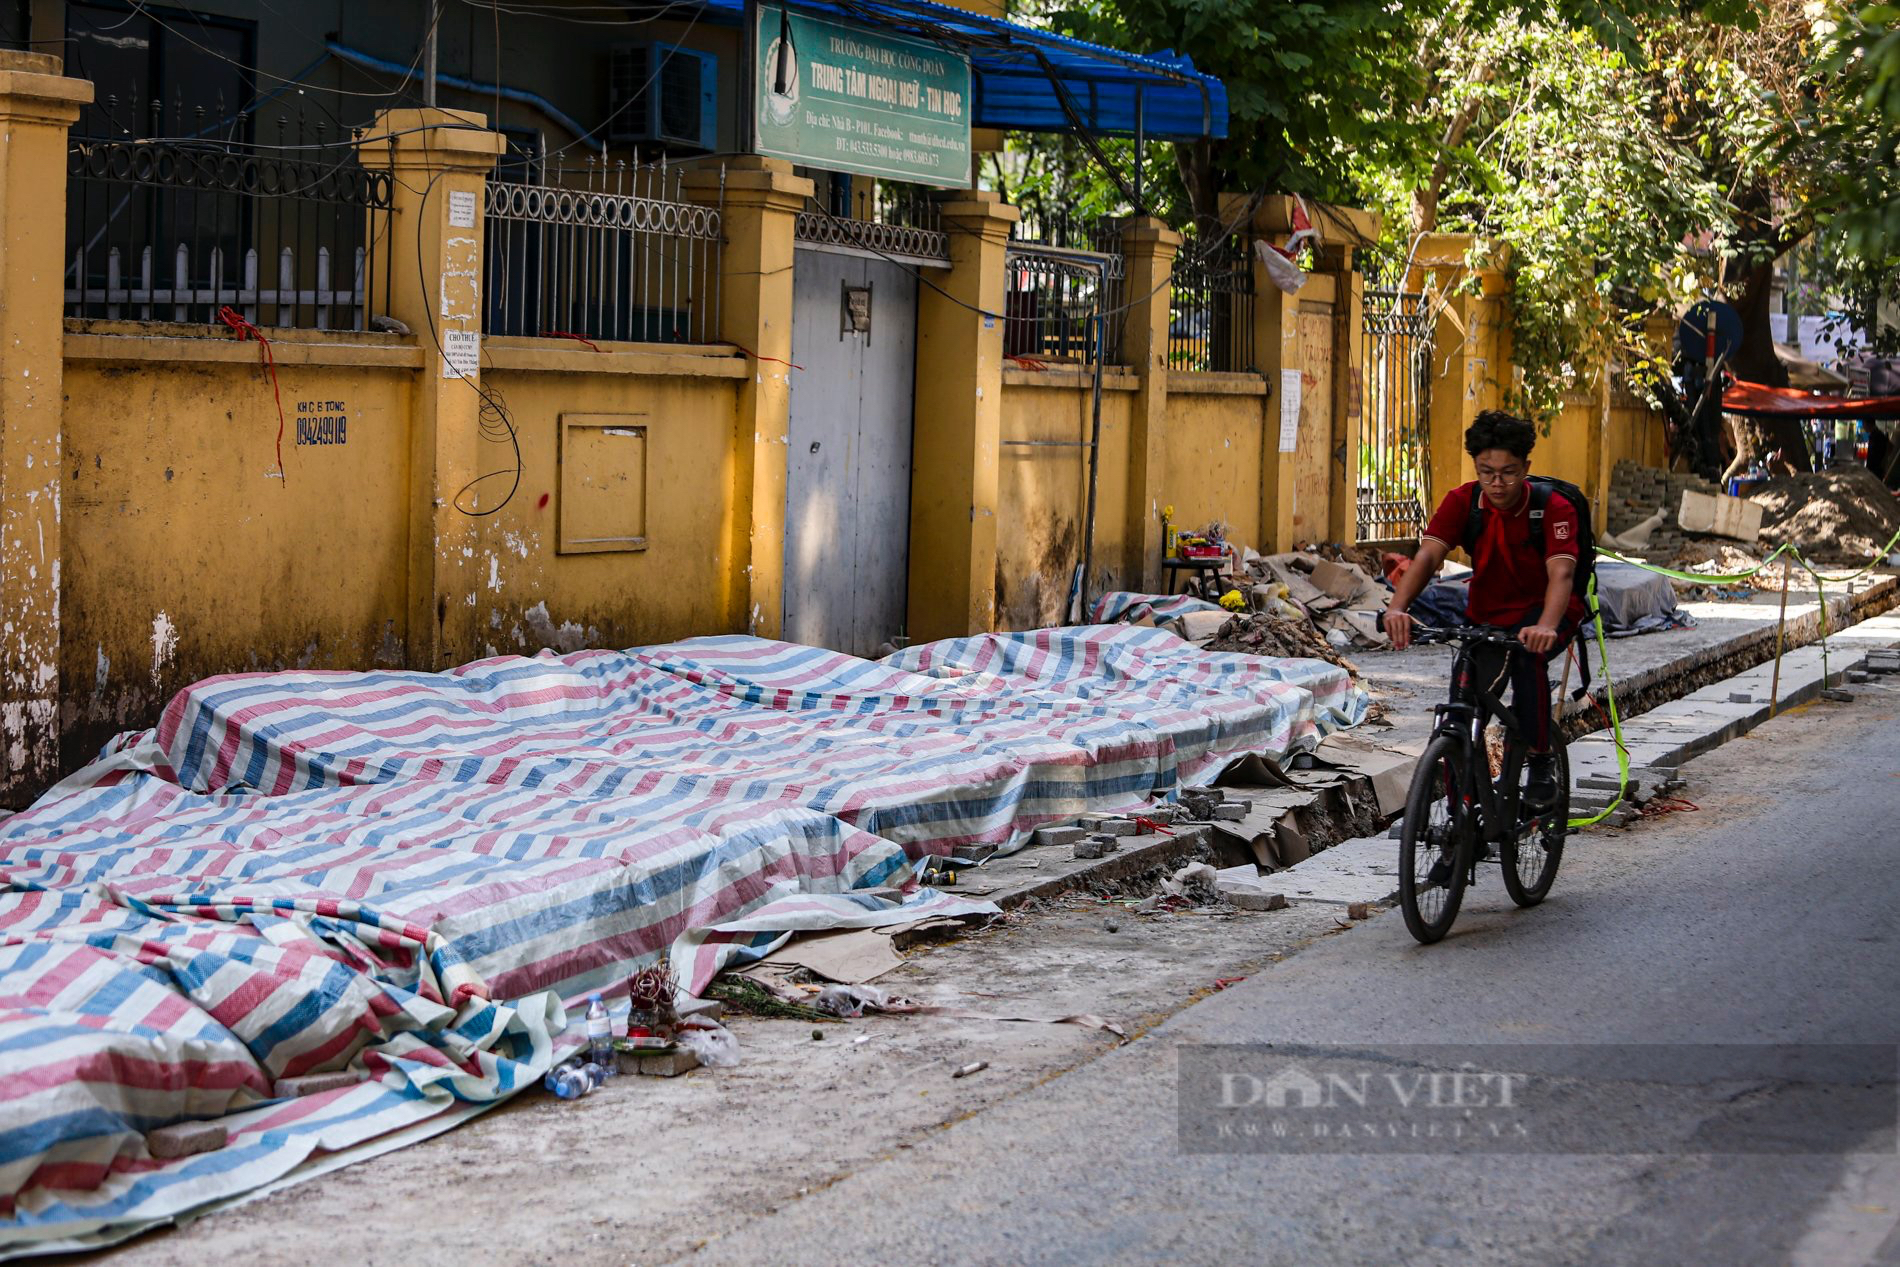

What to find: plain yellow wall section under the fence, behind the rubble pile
left=1159, top=387, right=1279, bottom=549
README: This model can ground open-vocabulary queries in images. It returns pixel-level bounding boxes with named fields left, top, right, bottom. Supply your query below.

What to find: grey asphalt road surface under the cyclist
left=694, top=684, right=1900, bottom=1265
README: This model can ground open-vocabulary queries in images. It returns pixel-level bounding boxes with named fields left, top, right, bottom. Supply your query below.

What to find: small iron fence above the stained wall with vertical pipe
left=1003, top=207, right=1127, bottom=365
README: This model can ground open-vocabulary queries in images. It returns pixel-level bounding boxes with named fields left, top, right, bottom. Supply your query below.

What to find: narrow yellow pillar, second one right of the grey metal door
left=1121, top=217, right=1182, bottom=595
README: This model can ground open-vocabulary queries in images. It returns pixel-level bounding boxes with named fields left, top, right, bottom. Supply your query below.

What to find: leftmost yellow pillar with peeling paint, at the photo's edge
left=0, top=51, right=93, bottom=805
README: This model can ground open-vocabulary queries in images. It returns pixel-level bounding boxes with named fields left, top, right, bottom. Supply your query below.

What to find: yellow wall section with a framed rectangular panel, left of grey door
left=471, top=351, right=751, bottom=655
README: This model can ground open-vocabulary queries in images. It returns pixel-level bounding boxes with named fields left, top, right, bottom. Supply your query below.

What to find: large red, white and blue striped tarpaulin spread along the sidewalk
left=0, top=627, right=1366, bottom=1256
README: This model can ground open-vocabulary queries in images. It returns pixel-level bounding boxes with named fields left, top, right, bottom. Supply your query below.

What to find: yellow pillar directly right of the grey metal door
left=906, top=192, right=1020, bottom=642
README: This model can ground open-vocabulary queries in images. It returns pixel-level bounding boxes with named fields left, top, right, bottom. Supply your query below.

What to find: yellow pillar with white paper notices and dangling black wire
left=359, top=110, right=515, bottom=671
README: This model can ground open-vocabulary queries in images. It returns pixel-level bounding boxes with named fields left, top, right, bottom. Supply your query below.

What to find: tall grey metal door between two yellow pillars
left=785, top=251, right=918, bottom=655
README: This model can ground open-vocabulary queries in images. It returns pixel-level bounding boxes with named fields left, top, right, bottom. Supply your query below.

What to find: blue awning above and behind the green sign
left=707, top=0, right=1227, bottom=141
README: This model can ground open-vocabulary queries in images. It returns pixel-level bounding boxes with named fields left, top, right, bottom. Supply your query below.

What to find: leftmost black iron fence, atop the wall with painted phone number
left=67, top=118, right=390, bottom=331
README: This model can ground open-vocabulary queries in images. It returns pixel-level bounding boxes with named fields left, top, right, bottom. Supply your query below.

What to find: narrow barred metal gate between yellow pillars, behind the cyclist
left=1355, top=289, right=1435, bottom=541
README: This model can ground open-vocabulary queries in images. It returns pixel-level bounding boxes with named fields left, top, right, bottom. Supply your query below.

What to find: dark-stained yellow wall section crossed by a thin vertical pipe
left=996, top=370, right=1134, bottom=629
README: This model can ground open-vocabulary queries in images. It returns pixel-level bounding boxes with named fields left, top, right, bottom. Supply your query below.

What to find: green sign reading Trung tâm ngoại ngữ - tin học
left=754, top=4, right=971, bottom=186
